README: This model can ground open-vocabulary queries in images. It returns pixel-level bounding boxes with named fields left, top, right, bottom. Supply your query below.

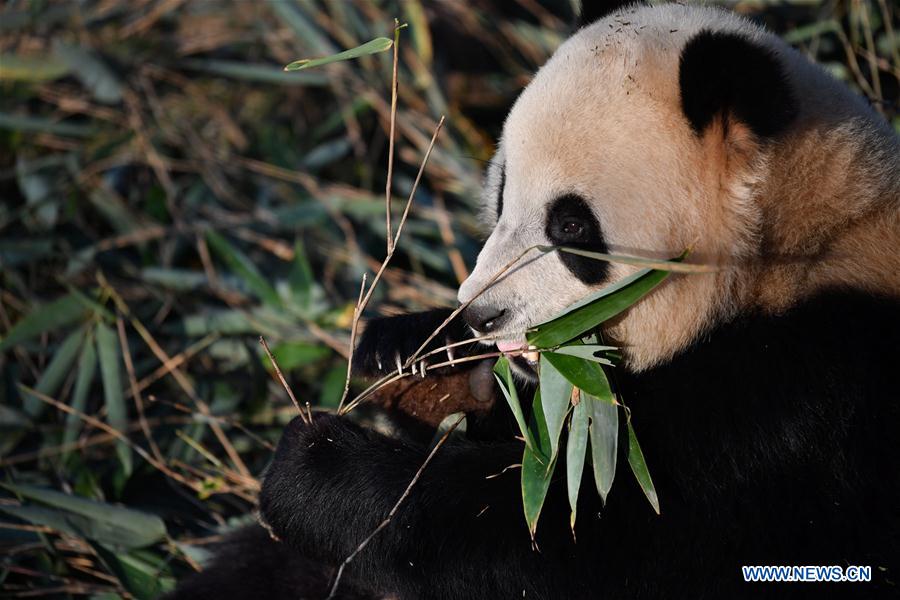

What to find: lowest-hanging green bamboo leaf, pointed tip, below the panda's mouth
left=522, top=390, right=556, bottom=539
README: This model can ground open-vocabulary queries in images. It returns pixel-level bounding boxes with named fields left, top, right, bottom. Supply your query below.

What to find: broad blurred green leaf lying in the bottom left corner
left=0, top=483, right=166, bottom=548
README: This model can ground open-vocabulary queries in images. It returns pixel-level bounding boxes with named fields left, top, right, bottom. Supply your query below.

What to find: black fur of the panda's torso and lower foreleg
left=222, top=292, right=900, bottom=600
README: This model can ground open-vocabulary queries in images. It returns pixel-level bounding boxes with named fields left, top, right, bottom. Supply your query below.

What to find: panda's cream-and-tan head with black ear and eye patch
left=458, top=4, right=884, bottom=370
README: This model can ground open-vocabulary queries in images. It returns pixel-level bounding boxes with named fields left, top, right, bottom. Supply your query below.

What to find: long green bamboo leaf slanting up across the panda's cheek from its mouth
left=526, top=269, right=669, bottom=348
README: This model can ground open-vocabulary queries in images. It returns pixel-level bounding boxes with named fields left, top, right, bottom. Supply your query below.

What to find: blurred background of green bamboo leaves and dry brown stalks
left=0, top=0, right=900, bottom=598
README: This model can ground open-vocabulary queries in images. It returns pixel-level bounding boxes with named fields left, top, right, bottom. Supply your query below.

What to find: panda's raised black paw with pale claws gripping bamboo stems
left=353, top=309, right=479, bottom=377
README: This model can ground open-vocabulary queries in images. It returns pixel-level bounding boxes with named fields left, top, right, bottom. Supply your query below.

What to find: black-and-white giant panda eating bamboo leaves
left=169, top=3, right=900, bottom=600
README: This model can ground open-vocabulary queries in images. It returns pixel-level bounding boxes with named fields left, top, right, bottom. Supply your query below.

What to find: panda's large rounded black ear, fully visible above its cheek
left=678, top=31, right=797, bottom=137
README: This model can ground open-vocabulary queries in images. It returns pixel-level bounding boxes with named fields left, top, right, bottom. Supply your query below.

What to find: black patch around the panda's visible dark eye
left=544, top=194, right=609, bottom=284
